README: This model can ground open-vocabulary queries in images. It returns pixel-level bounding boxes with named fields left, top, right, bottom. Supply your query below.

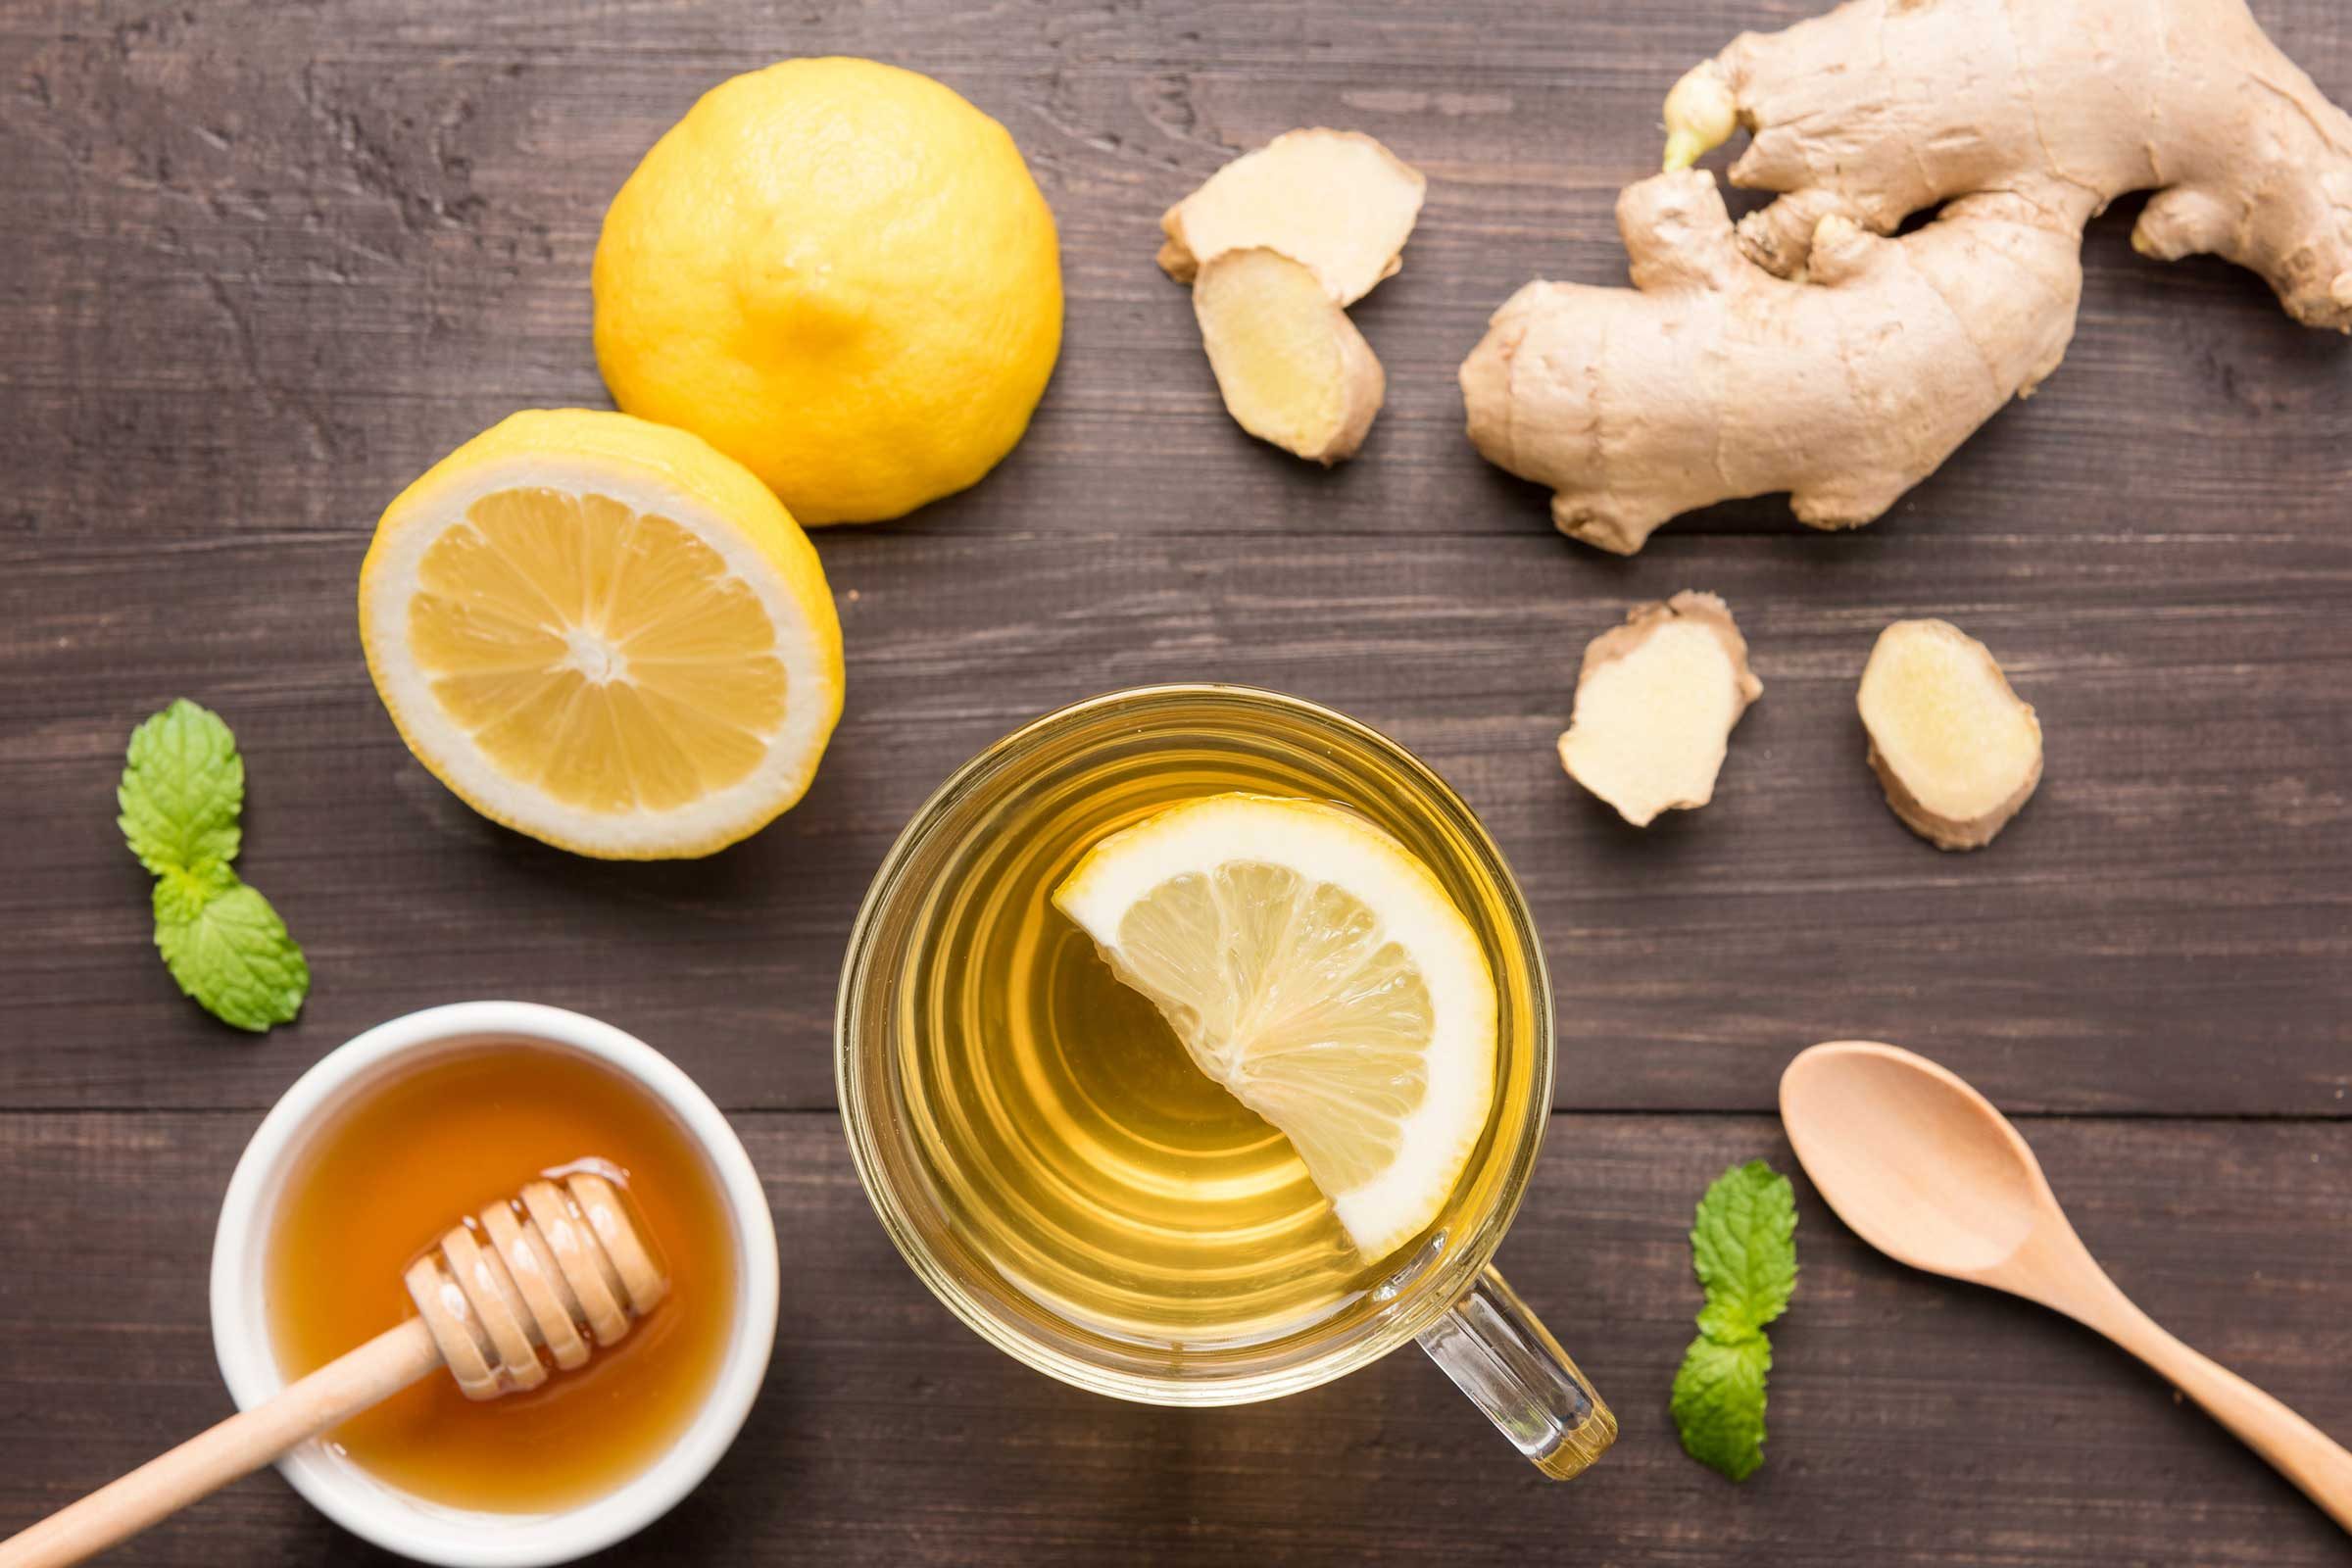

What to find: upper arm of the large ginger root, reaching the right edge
left=1693, top=0, right=2352, bottom=331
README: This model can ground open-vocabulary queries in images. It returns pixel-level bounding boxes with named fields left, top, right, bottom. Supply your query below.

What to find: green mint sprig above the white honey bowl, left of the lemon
left=116, top=698, right=311, bottom=1034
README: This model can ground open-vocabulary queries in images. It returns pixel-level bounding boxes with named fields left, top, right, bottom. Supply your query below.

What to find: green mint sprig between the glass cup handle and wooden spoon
left=1675, top=1159, right=1797, bottom=1481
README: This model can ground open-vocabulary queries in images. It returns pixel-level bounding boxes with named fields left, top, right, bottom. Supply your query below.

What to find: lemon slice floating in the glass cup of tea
left=1054, top=795, right=1495, bottom=1262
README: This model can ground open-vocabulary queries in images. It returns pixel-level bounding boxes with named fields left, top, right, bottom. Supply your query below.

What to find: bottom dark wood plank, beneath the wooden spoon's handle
left=0, top=1114, right=2352, bottom=1568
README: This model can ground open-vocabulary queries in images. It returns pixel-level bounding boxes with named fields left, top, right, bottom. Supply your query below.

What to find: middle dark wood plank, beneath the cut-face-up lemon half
left=0, top=534, right=2352, bottom=1116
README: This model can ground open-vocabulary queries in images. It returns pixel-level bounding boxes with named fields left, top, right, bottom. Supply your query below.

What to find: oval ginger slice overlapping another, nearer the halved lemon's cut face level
left=1193, top=249, right=1388, bottom=466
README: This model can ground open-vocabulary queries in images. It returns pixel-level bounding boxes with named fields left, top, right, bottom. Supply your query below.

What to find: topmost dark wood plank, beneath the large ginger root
left=0, top=0, right=2352, bottom=550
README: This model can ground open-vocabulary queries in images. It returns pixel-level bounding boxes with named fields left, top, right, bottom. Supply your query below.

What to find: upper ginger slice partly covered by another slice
left=1159, top=127, right=1428, bottom=306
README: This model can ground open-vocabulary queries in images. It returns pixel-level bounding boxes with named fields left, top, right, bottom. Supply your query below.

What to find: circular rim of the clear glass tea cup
left=833, top=682, right=1559, bottom=1405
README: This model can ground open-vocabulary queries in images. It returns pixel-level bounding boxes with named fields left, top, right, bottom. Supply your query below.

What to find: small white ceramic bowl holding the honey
left=212, top=1002, right=776, bottom=1568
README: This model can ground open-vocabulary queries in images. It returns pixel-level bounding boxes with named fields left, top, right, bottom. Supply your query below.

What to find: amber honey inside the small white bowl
left=264, top=1042, right=736, bottom=1514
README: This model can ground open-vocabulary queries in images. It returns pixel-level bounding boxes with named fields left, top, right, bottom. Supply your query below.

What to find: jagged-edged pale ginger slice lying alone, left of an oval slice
left=1559, top=592, right=1764, bottom=827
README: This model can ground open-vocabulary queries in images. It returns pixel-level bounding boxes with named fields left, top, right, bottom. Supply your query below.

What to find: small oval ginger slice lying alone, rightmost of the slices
left=1856, top=620, right=2041, bottom=849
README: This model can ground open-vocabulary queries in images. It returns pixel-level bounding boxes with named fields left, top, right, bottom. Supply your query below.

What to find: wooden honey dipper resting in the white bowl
left=0, top=1171, right=670, bottom=1568
